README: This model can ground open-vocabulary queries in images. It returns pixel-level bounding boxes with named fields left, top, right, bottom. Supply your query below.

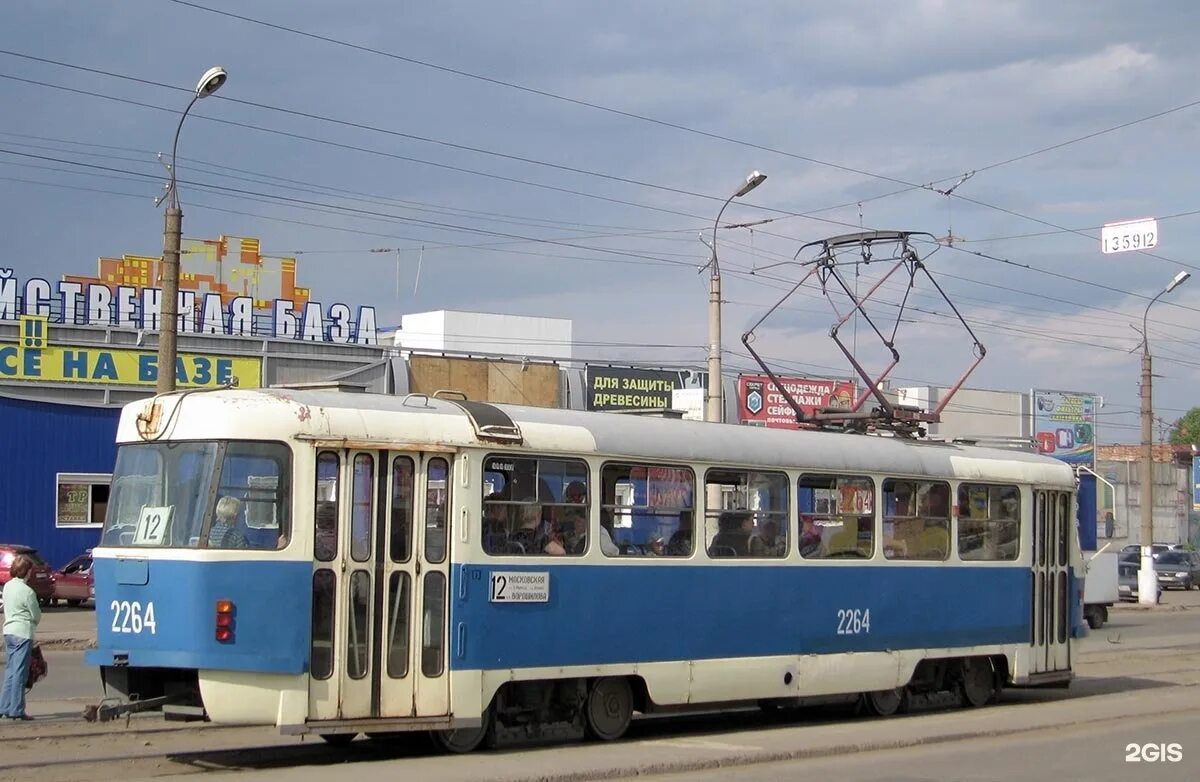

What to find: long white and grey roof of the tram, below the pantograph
left=118, top=389, right=1074, bottom=485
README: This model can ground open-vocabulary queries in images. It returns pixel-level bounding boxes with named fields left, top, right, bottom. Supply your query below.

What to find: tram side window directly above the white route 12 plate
left=481, top=455, right=590, bottom=557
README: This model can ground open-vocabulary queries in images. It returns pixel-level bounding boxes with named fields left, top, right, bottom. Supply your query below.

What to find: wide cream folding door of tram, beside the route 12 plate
left=310, top=450, right=451, bottom=720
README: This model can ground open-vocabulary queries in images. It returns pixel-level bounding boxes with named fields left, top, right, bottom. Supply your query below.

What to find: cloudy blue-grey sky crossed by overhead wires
left=0, top=0, right=1200, bottom=441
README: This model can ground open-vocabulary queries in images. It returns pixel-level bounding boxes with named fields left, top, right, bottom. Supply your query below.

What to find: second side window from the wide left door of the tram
left=600, top=464, right=696, bottom=557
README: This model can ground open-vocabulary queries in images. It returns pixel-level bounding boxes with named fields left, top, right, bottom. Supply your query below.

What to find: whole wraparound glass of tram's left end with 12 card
left=101, top=441, right=292, bottom=549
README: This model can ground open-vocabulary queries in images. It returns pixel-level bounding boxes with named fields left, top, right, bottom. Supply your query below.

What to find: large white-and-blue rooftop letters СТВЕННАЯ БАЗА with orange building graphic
left=0, top=236, right=378, bottom=345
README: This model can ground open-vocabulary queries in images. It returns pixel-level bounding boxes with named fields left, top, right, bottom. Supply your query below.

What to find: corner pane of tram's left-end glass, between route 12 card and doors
left=204, top=440, right=292, bottom=549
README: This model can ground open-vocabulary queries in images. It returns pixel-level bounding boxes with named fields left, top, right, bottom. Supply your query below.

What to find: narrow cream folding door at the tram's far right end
left=1030, top=491, right=1074, bottom=673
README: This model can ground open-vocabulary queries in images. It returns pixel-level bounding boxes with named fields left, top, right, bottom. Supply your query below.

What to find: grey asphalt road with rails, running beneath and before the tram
left=0, top=591, right=1200, bottom=782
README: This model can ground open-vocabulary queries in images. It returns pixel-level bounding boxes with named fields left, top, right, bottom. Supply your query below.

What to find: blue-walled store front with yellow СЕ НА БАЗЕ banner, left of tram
left=0, top=318, right=392, bottom=569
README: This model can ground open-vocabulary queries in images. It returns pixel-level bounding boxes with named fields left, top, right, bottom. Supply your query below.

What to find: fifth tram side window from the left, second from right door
left=883, top=479, right=950, bottom=561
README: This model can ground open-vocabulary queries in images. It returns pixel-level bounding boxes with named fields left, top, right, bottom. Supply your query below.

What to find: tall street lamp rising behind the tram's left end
left=157, top=66, right=229, bottom=393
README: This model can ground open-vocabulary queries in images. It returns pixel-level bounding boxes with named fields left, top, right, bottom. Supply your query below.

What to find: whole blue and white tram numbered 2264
left=89, top=389, right=1084, bottom=751
